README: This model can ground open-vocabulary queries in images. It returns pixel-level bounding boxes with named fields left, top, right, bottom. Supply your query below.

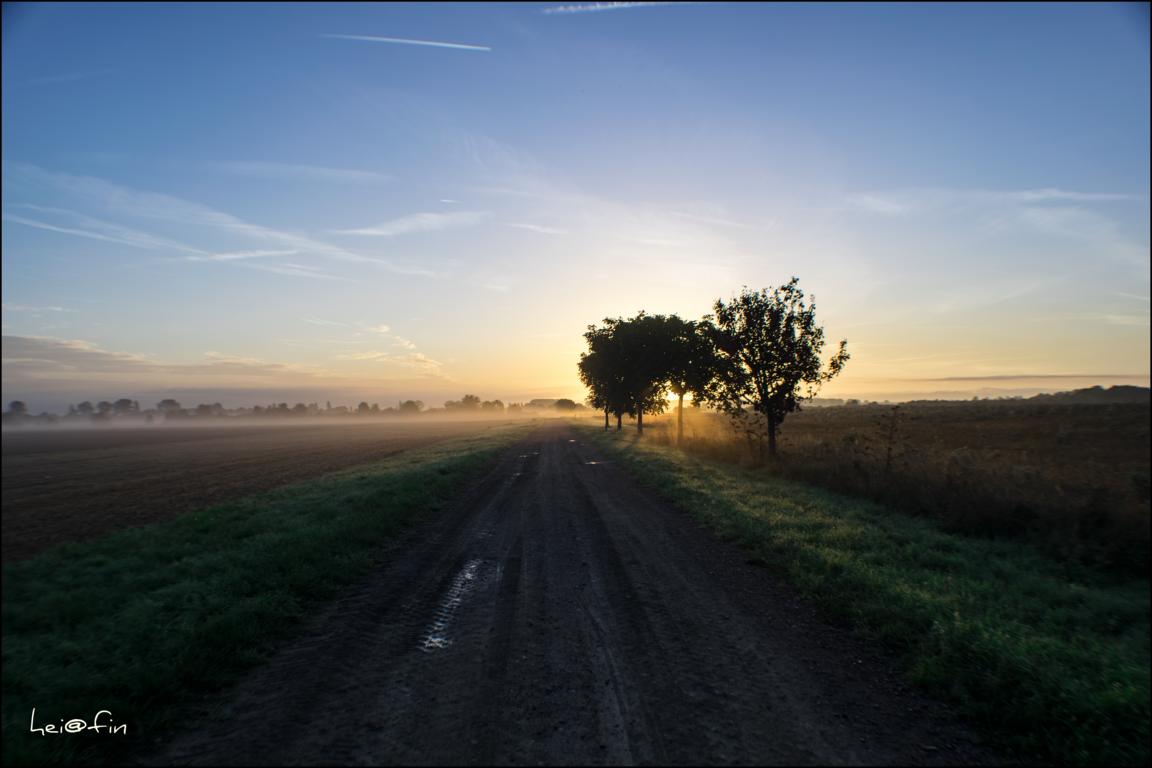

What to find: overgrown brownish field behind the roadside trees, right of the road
left=645, top=401, right=1152, bottom=573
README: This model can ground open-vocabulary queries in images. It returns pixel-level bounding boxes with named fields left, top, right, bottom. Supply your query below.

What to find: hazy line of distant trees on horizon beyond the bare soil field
left=3, top=395, right=584, bottom=426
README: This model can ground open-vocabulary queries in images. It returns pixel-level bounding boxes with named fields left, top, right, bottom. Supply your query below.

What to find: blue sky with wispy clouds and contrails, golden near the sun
left=2, top=2, right=1150, bottom=412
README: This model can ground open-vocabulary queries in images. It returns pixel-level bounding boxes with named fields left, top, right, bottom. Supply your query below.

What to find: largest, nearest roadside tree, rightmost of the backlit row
left=704, top=277, right=848, bottom=463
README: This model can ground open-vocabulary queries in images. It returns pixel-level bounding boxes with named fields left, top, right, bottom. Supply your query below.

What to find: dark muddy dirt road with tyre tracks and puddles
left=147, top=425, right=1001, bottom=765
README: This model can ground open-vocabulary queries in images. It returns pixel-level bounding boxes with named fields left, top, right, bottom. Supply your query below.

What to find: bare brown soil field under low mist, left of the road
left=0, top=420, right=520, bottom=562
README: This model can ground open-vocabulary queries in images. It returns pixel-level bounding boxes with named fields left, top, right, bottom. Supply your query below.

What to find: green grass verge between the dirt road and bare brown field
left=2, top=426, right=528, bottom=765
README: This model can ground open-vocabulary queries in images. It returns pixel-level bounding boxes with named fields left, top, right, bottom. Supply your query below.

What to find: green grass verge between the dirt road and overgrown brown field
left=581, top=427, right=1150, bottom=765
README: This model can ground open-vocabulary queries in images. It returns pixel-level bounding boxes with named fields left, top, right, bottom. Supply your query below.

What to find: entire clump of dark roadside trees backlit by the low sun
left=578, top=277, right=848, bottom=453
